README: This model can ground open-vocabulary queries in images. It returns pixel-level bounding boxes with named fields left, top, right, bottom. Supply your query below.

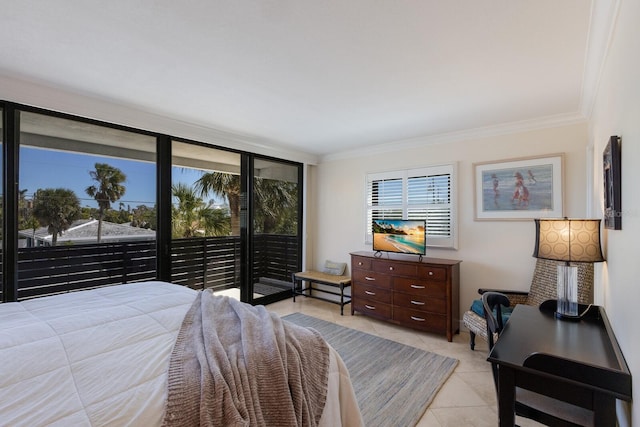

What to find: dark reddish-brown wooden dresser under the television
left=351, top=252, right=461, bottom=341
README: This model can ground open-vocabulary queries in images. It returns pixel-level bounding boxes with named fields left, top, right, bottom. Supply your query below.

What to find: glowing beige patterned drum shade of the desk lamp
left=533, top=218, right=604, bottom=262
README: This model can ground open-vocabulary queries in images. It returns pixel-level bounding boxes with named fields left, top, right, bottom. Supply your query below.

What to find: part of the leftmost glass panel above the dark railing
left=18, top=112, right=156, bottom=248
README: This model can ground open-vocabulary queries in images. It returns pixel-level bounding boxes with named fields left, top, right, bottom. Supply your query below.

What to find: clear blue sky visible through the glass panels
left=19, top=147, right=210, bottom=209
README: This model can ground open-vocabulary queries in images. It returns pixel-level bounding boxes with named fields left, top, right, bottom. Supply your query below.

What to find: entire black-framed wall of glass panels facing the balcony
left=0, top=101, right=303, bottom=304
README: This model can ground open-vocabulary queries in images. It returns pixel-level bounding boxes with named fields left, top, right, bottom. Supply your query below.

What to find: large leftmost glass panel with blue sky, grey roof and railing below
left=15, top=111, right=157, bottom=300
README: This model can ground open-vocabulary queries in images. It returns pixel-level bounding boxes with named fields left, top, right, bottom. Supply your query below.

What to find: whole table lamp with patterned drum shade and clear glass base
left=533, top=218, right=604, bottom=319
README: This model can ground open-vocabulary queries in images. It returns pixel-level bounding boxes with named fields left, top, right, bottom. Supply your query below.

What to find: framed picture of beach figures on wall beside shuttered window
left=473, top=153, right=564, bottom=221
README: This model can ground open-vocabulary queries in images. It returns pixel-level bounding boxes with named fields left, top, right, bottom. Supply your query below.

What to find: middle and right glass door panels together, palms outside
left=171, top=145, right=302, bottom=304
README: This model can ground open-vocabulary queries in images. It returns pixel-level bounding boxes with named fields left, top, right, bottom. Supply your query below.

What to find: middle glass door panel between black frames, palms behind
left=171, top=141, right=242, bottom=299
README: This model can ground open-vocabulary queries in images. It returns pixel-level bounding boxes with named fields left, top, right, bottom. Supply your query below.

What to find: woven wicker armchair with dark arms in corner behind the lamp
left=462, top=258, right=593, bottom=350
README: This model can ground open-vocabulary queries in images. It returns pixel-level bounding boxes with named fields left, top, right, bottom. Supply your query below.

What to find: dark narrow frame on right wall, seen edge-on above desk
left=602, top=135, right=622, bottom=230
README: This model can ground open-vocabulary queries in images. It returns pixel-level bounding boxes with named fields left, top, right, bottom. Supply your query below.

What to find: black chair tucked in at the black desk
left=482, top=292, right=594, bottom=427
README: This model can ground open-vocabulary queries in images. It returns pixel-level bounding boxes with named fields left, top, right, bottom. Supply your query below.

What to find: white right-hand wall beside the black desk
left=589, top=0, right=640, bottom=426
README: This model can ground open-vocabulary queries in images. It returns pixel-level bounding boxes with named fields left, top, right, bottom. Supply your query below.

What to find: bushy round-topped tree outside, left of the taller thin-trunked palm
left=33, top=188, right=80, bottom=246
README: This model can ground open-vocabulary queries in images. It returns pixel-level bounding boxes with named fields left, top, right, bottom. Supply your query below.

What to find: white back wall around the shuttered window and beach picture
left=307, top=123, right=587, bottom=315
